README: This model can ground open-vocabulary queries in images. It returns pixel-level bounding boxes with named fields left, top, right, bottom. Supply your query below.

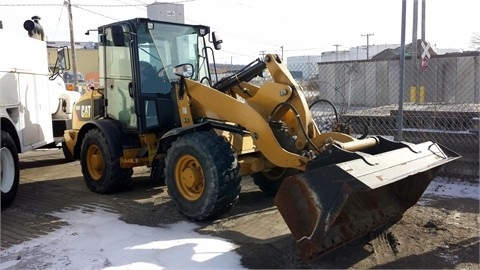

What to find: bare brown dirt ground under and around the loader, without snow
left=1, top=150, right=480, bottom=269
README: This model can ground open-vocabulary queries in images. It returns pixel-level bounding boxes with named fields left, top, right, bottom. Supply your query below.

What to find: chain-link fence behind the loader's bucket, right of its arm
left=212, top=51, right=480, bottom=181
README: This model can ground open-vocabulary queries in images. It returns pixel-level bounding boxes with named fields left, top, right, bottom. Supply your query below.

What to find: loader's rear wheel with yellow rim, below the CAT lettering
left=80, top=129, right=133, bottom=194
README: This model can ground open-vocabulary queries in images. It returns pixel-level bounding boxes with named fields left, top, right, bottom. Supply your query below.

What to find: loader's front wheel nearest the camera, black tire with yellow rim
left=165, top=132, right=241, bottom=220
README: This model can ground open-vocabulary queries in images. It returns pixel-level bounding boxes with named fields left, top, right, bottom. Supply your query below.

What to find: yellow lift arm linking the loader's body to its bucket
left=182, top=54, right=376, bottom=171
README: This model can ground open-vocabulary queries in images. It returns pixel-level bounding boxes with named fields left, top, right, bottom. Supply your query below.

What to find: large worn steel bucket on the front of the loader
left=275, top=137, right=460, bottom=261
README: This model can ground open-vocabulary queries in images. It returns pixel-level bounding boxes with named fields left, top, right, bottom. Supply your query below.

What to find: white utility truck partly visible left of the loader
left=0, top=16, right=80, bottom=209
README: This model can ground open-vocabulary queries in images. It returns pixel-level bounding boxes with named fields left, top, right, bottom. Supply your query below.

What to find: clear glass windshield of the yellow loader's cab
left=137, top=22, right=203, bottom=82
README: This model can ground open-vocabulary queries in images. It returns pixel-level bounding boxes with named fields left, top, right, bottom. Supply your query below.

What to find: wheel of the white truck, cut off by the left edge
left=0, top=130, right=20, bottom=209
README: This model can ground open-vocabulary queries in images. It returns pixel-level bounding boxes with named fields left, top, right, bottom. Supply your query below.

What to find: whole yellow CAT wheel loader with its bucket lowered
left=65, top=18, right=459, bottom=260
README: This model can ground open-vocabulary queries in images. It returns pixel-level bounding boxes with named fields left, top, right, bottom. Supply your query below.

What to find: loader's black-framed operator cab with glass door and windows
left=98, top=18, right=221, bottom=133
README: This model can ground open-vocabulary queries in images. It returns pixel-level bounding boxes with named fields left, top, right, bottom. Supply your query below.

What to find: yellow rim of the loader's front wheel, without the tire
left=175, top=155, right=205, bottom=201
